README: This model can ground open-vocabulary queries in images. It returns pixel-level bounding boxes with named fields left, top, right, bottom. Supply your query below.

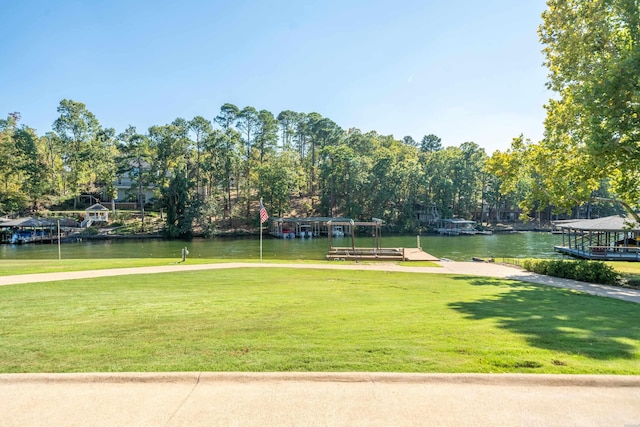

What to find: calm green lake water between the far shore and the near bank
left=0, top=232, right=562, bottom=261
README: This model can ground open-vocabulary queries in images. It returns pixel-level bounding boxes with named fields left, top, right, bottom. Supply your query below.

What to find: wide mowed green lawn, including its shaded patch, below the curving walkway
left=0, top=268, right=640, bottom=374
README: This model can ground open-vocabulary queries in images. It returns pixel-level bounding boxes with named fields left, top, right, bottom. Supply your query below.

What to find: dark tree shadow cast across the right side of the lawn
left=449, top=277, right=640, bottom=360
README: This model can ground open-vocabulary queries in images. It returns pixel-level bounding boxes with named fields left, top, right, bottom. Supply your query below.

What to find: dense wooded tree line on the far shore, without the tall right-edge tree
left=0, top=99, right=536, bottom=237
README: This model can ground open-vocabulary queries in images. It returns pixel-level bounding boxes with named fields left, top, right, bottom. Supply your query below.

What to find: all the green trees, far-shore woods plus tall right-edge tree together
left=0, top=0, right=640, bottom=237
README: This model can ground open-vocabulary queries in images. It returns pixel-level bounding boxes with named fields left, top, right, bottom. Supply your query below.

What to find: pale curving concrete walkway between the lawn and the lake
left=0, top=262, right=640, bottom=304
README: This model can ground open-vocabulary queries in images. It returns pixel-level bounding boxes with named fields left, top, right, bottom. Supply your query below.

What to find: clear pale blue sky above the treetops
left=0, top=0, right=551, bottom=154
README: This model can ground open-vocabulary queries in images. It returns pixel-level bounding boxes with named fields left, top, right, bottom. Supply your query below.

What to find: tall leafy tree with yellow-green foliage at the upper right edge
left=535, top=0, right=640, bottom=209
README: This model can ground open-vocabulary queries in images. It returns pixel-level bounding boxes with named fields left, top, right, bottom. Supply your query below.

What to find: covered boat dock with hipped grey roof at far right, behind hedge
left=554, top=215, right=640, bottom=261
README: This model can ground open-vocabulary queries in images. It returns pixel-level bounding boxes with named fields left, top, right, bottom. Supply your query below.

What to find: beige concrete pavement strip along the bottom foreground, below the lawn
left=0, top=372, right=640, bottom=427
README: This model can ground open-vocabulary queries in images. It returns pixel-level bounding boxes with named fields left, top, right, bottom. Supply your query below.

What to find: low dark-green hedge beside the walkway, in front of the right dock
left=523, top=260, right=620, bottom=285
